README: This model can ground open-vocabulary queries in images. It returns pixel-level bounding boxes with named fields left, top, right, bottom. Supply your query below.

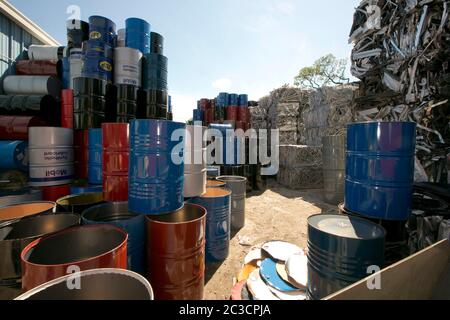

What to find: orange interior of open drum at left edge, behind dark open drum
left=0, top=202, right=56, bottom=225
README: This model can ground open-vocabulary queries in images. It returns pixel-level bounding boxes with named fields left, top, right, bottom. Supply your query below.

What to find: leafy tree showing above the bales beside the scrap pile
left=294, top=54, right=350, bottom=89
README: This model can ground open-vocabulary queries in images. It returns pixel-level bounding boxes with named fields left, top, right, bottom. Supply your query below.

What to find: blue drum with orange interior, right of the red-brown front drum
left=188, top=188, right=231, bottom=263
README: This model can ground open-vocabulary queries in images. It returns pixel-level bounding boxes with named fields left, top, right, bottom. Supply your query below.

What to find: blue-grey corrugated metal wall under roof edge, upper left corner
left=0, top=13, right=41, bottom=94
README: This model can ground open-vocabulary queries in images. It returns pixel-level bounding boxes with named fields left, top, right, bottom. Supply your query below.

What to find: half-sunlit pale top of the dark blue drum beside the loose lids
left=308, top=214, right=386, bottom=240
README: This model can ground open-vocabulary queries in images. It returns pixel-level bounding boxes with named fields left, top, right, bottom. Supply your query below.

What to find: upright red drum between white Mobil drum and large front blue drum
left=103, top=123, right=130, bottom=202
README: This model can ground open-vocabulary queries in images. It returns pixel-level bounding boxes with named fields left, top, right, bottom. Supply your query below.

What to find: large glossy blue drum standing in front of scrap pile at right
left=345, top=122, right=416, bottom=221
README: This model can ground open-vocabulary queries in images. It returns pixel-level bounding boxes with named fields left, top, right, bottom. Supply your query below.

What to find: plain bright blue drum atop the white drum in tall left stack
left=125, top=18, right=151, bottom=54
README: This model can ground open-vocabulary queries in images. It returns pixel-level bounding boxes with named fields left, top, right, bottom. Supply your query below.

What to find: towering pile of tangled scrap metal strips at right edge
left=350, top=0, right=450, bottom=182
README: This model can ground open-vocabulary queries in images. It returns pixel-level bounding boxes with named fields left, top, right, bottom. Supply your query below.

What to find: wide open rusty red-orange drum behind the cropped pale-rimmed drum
left=21, top=225, right=128, bottom=292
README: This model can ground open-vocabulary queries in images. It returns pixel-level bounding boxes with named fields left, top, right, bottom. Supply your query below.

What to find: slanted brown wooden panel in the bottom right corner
left=326, top=240, right=450, bottom=300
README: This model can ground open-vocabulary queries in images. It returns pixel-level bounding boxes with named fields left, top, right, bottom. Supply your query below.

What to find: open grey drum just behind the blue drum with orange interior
left=217, top=176, right=247, bottom=231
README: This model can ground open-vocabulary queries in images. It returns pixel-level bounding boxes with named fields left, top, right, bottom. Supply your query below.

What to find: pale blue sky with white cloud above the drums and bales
left=10, top=0, right=360, bottom=121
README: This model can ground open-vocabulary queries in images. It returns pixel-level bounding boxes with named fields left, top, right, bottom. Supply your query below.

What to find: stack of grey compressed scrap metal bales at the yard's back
left=250, top=85, right=356, bottom=189
